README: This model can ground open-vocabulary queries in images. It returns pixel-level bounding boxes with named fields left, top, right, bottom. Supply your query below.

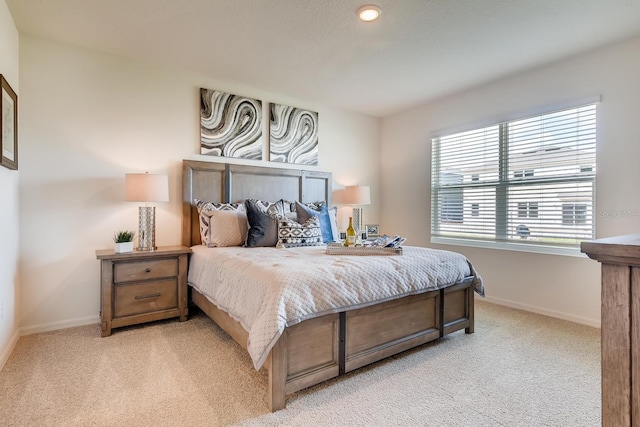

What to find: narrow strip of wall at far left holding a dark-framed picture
left=0, top=0, right=21, bottom=369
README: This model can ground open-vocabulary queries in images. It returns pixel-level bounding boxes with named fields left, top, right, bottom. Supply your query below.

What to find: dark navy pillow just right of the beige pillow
left=244, top=199, right=279, bottom=248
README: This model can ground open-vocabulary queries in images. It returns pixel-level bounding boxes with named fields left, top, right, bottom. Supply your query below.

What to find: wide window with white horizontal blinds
left=431, top=104, right=596, bottom=251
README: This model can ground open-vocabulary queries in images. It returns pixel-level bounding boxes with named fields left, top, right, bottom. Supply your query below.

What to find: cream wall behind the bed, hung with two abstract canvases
left=20, top=35, right=380, bottom=333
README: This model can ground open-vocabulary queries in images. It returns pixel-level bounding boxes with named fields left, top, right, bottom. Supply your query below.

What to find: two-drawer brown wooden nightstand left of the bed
left=96, top=246, right=191, bottom=337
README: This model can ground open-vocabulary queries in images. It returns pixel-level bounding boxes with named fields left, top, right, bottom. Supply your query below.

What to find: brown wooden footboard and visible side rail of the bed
left=192, top=277, right=474, bottom=411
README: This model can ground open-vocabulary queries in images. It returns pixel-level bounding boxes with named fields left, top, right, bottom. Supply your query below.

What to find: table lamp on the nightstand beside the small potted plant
left=124, top=172, right=169, bottom=251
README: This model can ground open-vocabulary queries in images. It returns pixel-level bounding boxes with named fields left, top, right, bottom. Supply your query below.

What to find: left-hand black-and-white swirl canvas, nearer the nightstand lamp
left=200, top=89, right=264, bottom=160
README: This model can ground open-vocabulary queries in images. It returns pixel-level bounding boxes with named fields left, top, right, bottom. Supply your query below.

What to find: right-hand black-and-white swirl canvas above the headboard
left=269, top=104, right=318, bottom=165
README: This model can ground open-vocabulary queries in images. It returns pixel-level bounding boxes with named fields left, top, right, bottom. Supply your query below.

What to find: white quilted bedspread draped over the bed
left=188, top=245, right=484, bottom=369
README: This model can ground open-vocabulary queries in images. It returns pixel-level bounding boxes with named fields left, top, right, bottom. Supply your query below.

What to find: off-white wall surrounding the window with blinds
left=381, top=39, right=640, bottom=326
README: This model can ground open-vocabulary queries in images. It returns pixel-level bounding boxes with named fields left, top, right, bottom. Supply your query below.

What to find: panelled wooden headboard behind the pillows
left=182, top=160, right=332, bottom=246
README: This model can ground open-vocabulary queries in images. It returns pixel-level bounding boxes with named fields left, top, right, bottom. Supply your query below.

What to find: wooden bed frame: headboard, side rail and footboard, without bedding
left=182, top=160, right=474, bottom=411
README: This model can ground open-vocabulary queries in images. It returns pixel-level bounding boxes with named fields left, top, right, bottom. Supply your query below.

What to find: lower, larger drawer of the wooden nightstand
left=113, top=278, right=178, bottom=317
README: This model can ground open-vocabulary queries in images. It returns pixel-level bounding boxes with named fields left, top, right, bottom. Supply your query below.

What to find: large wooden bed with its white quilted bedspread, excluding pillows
left=182, top=160, right=484, bottom=411
